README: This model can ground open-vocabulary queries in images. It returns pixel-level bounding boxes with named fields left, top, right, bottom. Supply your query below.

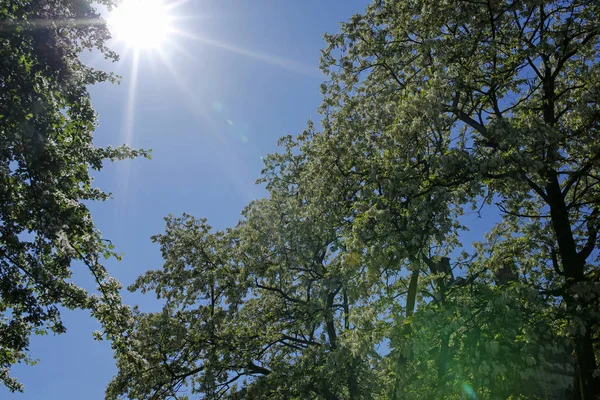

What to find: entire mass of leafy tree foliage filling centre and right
left=108, top=0, right=600, bottom=399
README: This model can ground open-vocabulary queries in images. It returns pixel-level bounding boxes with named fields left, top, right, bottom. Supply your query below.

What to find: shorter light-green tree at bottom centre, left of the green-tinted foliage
left=107, top=188, right=390, bottom=399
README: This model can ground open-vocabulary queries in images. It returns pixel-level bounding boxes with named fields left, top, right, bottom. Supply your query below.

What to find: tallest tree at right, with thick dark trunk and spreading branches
left=316, top=1, right=600, bottom=399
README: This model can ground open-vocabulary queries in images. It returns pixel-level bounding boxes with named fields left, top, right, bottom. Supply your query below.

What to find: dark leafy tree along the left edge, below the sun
left=0, top=0, right=147, bottom=391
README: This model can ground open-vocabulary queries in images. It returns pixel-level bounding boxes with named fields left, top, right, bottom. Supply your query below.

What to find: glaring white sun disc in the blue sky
left=108, top=0, right=173, bottom=50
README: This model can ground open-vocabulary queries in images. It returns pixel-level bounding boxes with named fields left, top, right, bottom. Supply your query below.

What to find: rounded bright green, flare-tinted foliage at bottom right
left=388, top=236, right=574, bottom=399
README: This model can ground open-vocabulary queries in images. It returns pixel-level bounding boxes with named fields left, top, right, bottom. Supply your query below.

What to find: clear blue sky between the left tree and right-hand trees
left=0, top=0, right=367, bottom=400
